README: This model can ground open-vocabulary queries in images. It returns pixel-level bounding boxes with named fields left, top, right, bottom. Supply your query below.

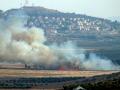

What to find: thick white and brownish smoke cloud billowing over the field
left=0, top=15, right=120, bottom=70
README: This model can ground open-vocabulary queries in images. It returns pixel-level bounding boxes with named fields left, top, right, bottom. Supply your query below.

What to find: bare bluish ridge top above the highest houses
left=0, top=6, right=108, bottom=20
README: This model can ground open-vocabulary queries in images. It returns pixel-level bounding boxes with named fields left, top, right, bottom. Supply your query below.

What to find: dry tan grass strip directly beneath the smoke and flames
left=0, top=69, right=118, bottom=77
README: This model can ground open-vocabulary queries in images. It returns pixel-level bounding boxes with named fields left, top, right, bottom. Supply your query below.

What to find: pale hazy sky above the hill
left=0, top=0, right=120, bottom=18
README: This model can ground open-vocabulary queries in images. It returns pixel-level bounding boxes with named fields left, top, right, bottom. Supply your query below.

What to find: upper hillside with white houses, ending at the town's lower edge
left=0, top=7, right=120, bottom=42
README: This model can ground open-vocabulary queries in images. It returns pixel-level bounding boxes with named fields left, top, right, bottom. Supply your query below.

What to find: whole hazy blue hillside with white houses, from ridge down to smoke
left=0, top=7, right=120, bottom=64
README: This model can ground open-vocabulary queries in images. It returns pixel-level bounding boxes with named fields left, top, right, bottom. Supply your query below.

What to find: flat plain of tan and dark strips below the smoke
left=0, top=69, right=119, bottom=90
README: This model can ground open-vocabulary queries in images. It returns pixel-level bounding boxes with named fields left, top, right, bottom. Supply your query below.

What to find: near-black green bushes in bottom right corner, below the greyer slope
left=64, top=79, right=120, bottom=90
